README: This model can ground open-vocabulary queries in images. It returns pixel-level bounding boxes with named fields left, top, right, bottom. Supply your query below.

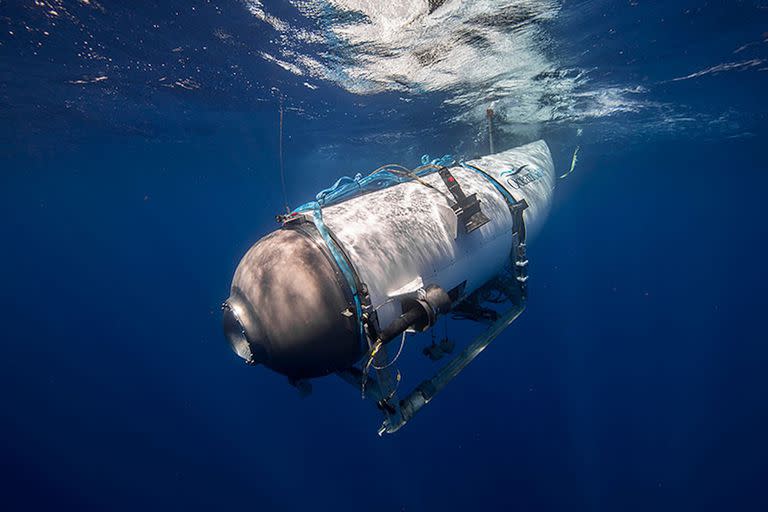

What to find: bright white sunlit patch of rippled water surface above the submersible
left=245, top=0, right=650, bottom=129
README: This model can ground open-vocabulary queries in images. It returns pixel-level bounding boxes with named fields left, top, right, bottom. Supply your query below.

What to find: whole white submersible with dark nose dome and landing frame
left=222, top=140, right=555, bottom=432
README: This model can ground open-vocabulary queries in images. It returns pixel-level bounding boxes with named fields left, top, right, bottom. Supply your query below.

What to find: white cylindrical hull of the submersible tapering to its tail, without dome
left=323, top=140, right=555, bottom=326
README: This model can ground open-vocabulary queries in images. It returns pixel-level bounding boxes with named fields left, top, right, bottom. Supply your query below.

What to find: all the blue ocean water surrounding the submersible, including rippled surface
left=0, top=0, right=768, bottom=511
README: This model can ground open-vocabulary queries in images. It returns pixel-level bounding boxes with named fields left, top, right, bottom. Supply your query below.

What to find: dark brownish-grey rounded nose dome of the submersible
left=223, top=225, right=362, bottom=378
